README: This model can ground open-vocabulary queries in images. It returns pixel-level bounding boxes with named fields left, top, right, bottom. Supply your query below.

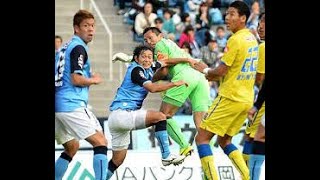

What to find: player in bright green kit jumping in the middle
left=143, top=27, right=210, bottom=157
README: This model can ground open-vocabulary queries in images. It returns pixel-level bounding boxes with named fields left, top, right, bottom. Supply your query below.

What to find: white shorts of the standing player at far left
left=55, top=107, right=102, bottom=144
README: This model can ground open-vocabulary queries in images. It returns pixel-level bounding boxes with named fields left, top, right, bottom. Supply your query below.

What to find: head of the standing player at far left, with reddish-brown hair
left=73, top=10, right=95, bottom=43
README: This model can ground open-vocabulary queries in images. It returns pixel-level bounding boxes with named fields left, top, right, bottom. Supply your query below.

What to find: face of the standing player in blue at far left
left=75, top=18, right=95, bottom=43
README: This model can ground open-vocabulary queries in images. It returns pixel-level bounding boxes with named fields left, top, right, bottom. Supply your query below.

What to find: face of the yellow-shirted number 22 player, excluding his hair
left=226, top=7, right=245, bottom=33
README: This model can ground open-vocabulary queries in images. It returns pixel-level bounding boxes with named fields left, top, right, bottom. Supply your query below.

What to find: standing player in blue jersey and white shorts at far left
left=55, top=10, right=108, bottom=180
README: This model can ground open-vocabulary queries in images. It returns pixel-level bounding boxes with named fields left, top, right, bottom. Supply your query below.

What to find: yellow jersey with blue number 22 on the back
left=219, top=29, right=258, bottom=103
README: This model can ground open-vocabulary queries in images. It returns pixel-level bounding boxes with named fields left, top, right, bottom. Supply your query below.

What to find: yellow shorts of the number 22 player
left=200, top=95, right=252, bottom=137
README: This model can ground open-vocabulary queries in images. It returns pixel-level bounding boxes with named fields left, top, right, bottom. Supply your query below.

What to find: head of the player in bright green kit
left=143, top=27, right=163, bottom=48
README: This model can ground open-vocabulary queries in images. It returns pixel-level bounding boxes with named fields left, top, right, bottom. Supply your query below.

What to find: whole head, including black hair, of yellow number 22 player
left=225, top=1, right=250, bottom=33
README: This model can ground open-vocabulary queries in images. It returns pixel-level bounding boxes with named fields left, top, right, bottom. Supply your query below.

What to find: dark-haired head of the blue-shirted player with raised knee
left=132, top=45, right=153, bottom=69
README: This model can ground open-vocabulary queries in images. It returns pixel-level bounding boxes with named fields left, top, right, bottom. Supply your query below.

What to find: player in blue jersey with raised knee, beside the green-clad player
left=108, top=46, right=187, bottom=179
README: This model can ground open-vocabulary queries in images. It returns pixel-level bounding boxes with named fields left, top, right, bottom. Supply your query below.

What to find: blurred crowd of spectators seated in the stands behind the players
left=114, top=0, right=264, bottom=114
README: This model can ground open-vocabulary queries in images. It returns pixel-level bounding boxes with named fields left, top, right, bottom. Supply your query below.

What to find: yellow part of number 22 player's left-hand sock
left=200, top=155, right=218, bottom=180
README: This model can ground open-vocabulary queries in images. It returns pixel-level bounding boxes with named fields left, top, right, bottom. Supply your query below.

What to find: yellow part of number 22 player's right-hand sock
left=228, top=149, right=250, bottom=180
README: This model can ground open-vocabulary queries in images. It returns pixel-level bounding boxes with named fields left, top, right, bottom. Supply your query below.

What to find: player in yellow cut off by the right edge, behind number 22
left=242, top=13, right=265, bottom=167
